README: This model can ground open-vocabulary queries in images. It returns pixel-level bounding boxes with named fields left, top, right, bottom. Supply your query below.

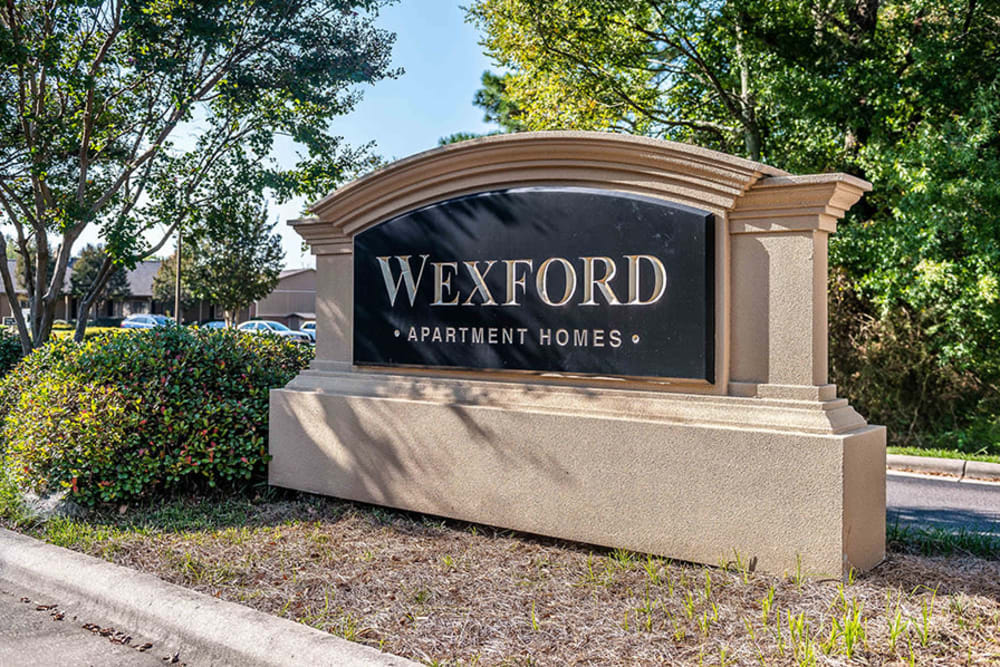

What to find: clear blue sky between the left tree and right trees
left=272, top=0, right=494, bottom=267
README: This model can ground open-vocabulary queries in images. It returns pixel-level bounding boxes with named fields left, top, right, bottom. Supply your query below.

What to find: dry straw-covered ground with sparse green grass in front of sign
left=2, top=492, right=1000, bottom=665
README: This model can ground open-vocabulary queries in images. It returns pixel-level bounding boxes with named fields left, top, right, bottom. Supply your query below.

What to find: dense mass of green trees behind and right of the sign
left=469, top=0, right=1000, bottom=443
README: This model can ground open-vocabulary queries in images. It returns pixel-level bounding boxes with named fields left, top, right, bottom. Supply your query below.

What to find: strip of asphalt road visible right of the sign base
left=885, top=471, right=1000, bottom=536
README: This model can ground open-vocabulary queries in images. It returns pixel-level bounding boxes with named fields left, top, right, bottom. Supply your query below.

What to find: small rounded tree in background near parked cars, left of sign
left=187, top=197, right=285, bottom=326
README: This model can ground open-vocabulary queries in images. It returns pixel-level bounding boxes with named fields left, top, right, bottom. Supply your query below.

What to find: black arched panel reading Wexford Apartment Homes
left=354, top=187, right=715, bottom=382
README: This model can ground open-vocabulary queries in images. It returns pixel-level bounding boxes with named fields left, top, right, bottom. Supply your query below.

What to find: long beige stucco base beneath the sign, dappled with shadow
left=270, top=370, right=885, bottom=577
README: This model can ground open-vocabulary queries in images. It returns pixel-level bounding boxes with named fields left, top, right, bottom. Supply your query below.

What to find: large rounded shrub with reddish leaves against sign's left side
left=0, top=327, right=312, bottom=505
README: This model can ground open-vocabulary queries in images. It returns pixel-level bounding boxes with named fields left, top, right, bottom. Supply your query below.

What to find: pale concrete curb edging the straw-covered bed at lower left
left=0, top=529, right=417, bottom=667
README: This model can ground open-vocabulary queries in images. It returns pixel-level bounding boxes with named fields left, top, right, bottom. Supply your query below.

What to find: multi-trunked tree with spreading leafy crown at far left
left=0, top=0, right=396, bottom=350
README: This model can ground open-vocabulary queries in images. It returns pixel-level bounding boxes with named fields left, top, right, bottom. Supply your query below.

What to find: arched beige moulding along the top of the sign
left=292, top=131, right=788, bottom=254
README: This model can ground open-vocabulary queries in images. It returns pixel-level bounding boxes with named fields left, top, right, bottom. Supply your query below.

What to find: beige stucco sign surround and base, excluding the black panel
left=270, top=132, right=885, bottom=576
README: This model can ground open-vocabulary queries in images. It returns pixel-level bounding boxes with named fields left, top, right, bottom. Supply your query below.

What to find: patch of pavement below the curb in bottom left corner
left=0, top=579, right=183, bottom=667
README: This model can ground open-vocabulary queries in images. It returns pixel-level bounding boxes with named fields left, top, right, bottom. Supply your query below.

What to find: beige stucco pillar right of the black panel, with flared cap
left=729, top=174, right=869, bottom=400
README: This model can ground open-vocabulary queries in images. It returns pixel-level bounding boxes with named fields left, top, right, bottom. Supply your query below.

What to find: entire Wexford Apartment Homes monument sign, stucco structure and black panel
left=269, top=132, right=885, bottom=576
